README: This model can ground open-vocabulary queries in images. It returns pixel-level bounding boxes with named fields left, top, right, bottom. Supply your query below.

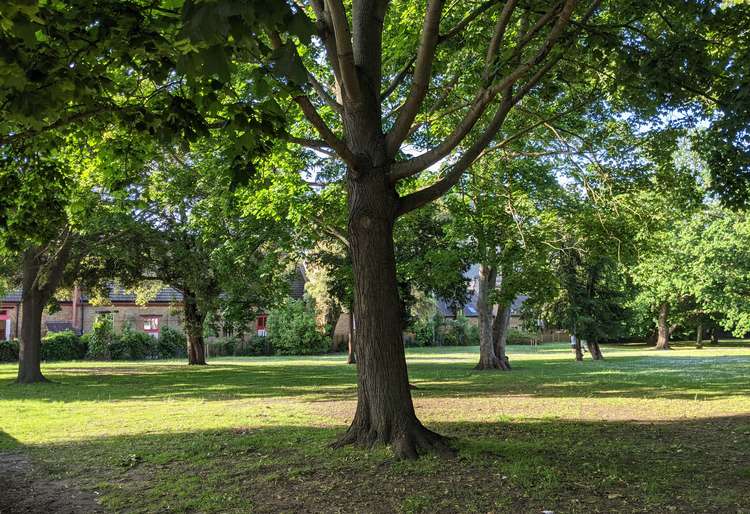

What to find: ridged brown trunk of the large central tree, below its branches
left=334, top=167, right=451, bottom=459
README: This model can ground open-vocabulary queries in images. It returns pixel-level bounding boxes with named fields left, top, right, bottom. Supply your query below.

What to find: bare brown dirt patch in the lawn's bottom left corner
left=0, top=453, right=104, bottom=514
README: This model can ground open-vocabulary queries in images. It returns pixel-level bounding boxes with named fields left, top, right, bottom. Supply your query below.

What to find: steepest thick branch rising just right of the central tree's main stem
left=386, top=0, right=445, bottom=155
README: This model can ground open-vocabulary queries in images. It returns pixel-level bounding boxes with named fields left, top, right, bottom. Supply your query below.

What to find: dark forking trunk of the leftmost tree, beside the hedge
left=16, top=242, right=70, bottom=384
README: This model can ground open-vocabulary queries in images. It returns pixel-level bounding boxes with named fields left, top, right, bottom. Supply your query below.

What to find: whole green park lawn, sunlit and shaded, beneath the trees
left=0, top=343, right=750, bottom=513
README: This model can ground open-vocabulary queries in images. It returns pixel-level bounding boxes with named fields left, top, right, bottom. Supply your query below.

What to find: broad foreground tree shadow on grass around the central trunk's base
left=7, top=416, right=750, bottom=512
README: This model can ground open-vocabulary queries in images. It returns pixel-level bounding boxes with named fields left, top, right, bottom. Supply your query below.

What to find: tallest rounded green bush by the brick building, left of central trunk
left=267, top=298, right=331, bottom=355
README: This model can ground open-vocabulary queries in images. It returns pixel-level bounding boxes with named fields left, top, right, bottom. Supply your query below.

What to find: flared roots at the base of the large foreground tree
left=331, top=419, right=456, bottom=460
